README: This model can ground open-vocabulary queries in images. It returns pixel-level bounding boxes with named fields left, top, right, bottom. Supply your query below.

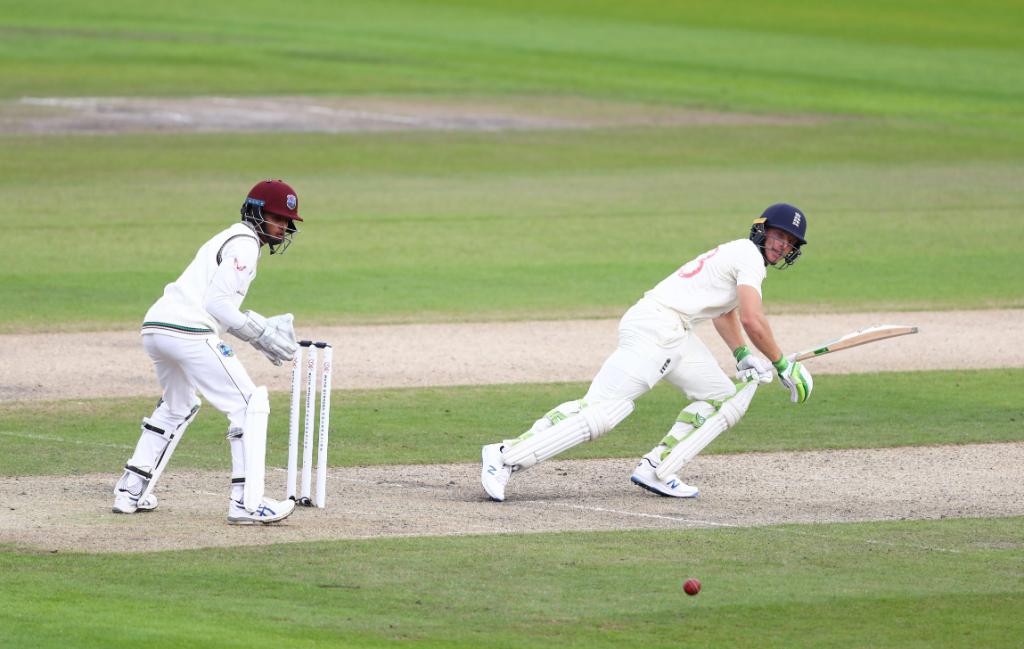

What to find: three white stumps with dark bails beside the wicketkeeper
left=288, top=340, right=334, bottom=508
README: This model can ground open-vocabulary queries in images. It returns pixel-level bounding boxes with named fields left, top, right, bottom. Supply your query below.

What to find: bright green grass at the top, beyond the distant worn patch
left=0, top=0, right=1024, bottom=123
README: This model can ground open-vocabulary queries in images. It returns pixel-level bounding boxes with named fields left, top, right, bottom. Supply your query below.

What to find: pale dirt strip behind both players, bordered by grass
left=0, top=309, right=1024, bottom=401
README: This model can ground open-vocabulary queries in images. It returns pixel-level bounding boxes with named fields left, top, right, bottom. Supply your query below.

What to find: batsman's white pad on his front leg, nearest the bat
left=655, top=381, right=758, bottom=480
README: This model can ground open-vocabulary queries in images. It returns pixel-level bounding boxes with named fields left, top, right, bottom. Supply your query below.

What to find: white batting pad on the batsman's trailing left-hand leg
left=502, top=400, right=633, bottom=469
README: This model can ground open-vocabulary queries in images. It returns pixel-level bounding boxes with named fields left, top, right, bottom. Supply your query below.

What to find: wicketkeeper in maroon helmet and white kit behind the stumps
left=114, top=180, right=302, bottom=524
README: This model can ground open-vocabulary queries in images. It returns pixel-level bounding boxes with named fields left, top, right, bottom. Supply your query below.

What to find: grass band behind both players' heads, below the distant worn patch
left=0, top=123, right=1024, bottom=331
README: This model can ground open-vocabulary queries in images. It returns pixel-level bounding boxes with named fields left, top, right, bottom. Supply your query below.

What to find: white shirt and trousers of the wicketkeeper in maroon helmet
left=142, top=223, right=260, bottom=430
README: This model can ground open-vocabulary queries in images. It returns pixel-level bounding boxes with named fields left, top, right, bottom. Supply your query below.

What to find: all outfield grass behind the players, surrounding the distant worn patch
left=0, top=0, right=1024, bottom=332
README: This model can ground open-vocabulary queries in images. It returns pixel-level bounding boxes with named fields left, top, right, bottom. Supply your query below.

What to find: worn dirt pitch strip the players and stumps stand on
left=0, top=443, right=1024, bottom=552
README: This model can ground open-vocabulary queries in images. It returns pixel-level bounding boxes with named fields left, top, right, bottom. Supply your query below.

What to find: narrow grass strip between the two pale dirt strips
left=0, top=370, right=1024, bottom=475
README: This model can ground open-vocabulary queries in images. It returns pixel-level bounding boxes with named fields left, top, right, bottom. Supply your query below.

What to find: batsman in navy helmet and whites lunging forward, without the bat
left=480, top=204, right=813, bottom=502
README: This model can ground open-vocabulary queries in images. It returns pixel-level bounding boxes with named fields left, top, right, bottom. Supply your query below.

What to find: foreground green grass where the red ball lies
left=0, top=518, right=1024, bottom=649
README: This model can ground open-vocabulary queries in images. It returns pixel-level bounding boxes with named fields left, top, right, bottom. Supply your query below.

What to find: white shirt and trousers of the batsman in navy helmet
left=584, top=239, right=765, bottom=402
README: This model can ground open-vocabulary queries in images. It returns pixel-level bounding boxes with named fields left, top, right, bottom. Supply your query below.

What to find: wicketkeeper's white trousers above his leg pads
left=142, top=333, right=256, bottom=430
